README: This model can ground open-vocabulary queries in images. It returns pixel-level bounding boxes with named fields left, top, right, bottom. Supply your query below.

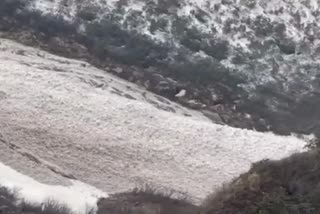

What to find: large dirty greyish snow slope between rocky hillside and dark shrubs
left=0, top=39, right=305, bottom=201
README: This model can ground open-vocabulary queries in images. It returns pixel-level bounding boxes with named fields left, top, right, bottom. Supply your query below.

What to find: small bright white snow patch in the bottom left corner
left=0, top=163, right=108, bottom=214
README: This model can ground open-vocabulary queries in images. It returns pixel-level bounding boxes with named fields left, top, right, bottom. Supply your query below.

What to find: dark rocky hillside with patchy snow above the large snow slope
left=1, top=0, right=320, bottom=135
